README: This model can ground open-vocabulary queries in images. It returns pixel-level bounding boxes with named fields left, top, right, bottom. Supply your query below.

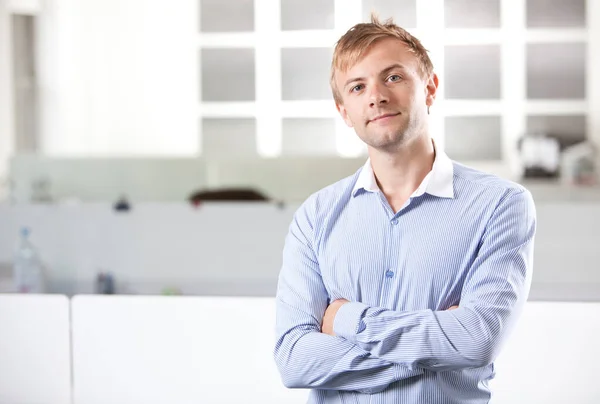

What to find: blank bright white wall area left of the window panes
left=37, top=0, right=198, bottom=157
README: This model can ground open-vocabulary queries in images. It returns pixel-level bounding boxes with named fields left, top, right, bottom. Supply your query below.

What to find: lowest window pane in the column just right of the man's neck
left=445, top=116, right=502, bottom=161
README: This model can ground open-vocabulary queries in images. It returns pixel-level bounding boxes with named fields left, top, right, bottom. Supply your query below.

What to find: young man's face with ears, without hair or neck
left=335, top=38, right=437, bottom=151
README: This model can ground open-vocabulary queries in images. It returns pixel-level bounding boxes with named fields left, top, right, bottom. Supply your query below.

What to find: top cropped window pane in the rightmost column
left=527, top=0, right=584, bottom=28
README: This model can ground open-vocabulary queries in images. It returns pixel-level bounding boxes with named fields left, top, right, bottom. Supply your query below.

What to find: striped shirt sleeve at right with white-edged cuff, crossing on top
left=334, top=191, right=536, bottom=371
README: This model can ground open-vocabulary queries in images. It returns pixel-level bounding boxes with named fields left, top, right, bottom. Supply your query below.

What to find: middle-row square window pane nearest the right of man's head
left=445, top=45, right=500, bottom=99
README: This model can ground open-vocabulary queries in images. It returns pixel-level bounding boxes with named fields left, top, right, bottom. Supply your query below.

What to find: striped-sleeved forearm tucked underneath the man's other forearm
left=275, top=302, right=423, bottom=393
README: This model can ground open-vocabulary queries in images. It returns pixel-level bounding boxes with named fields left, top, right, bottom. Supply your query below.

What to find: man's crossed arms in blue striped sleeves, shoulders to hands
left=275, top=191, right=535, bottom=393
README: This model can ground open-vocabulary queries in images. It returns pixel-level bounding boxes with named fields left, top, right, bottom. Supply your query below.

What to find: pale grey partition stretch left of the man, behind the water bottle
left=0, top=204, right=291, bottom=294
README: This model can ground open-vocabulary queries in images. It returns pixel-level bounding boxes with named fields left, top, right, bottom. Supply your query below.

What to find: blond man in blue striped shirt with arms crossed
left=275, top=14, right=536, bottom=404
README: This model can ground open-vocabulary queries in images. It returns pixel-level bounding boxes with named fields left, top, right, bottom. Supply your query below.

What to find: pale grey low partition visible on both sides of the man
left=0, top=202, right=600, bottom=301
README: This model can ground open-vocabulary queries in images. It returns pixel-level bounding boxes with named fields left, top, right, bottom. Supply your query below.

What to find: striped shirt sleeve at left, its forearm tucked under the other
left=275, top=197, right=423, bottom=393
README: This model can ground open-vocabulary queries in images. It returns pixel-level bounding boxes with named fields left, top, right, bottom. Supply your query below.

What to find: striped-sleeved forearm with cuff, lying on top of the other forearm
left=336, top=303, right=500, bottom=371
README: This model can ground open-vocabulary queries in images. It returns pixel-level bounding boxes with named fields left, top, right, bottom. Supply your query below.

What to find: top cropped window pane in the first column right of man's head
left=444, top=0, right=500, bottom=28
